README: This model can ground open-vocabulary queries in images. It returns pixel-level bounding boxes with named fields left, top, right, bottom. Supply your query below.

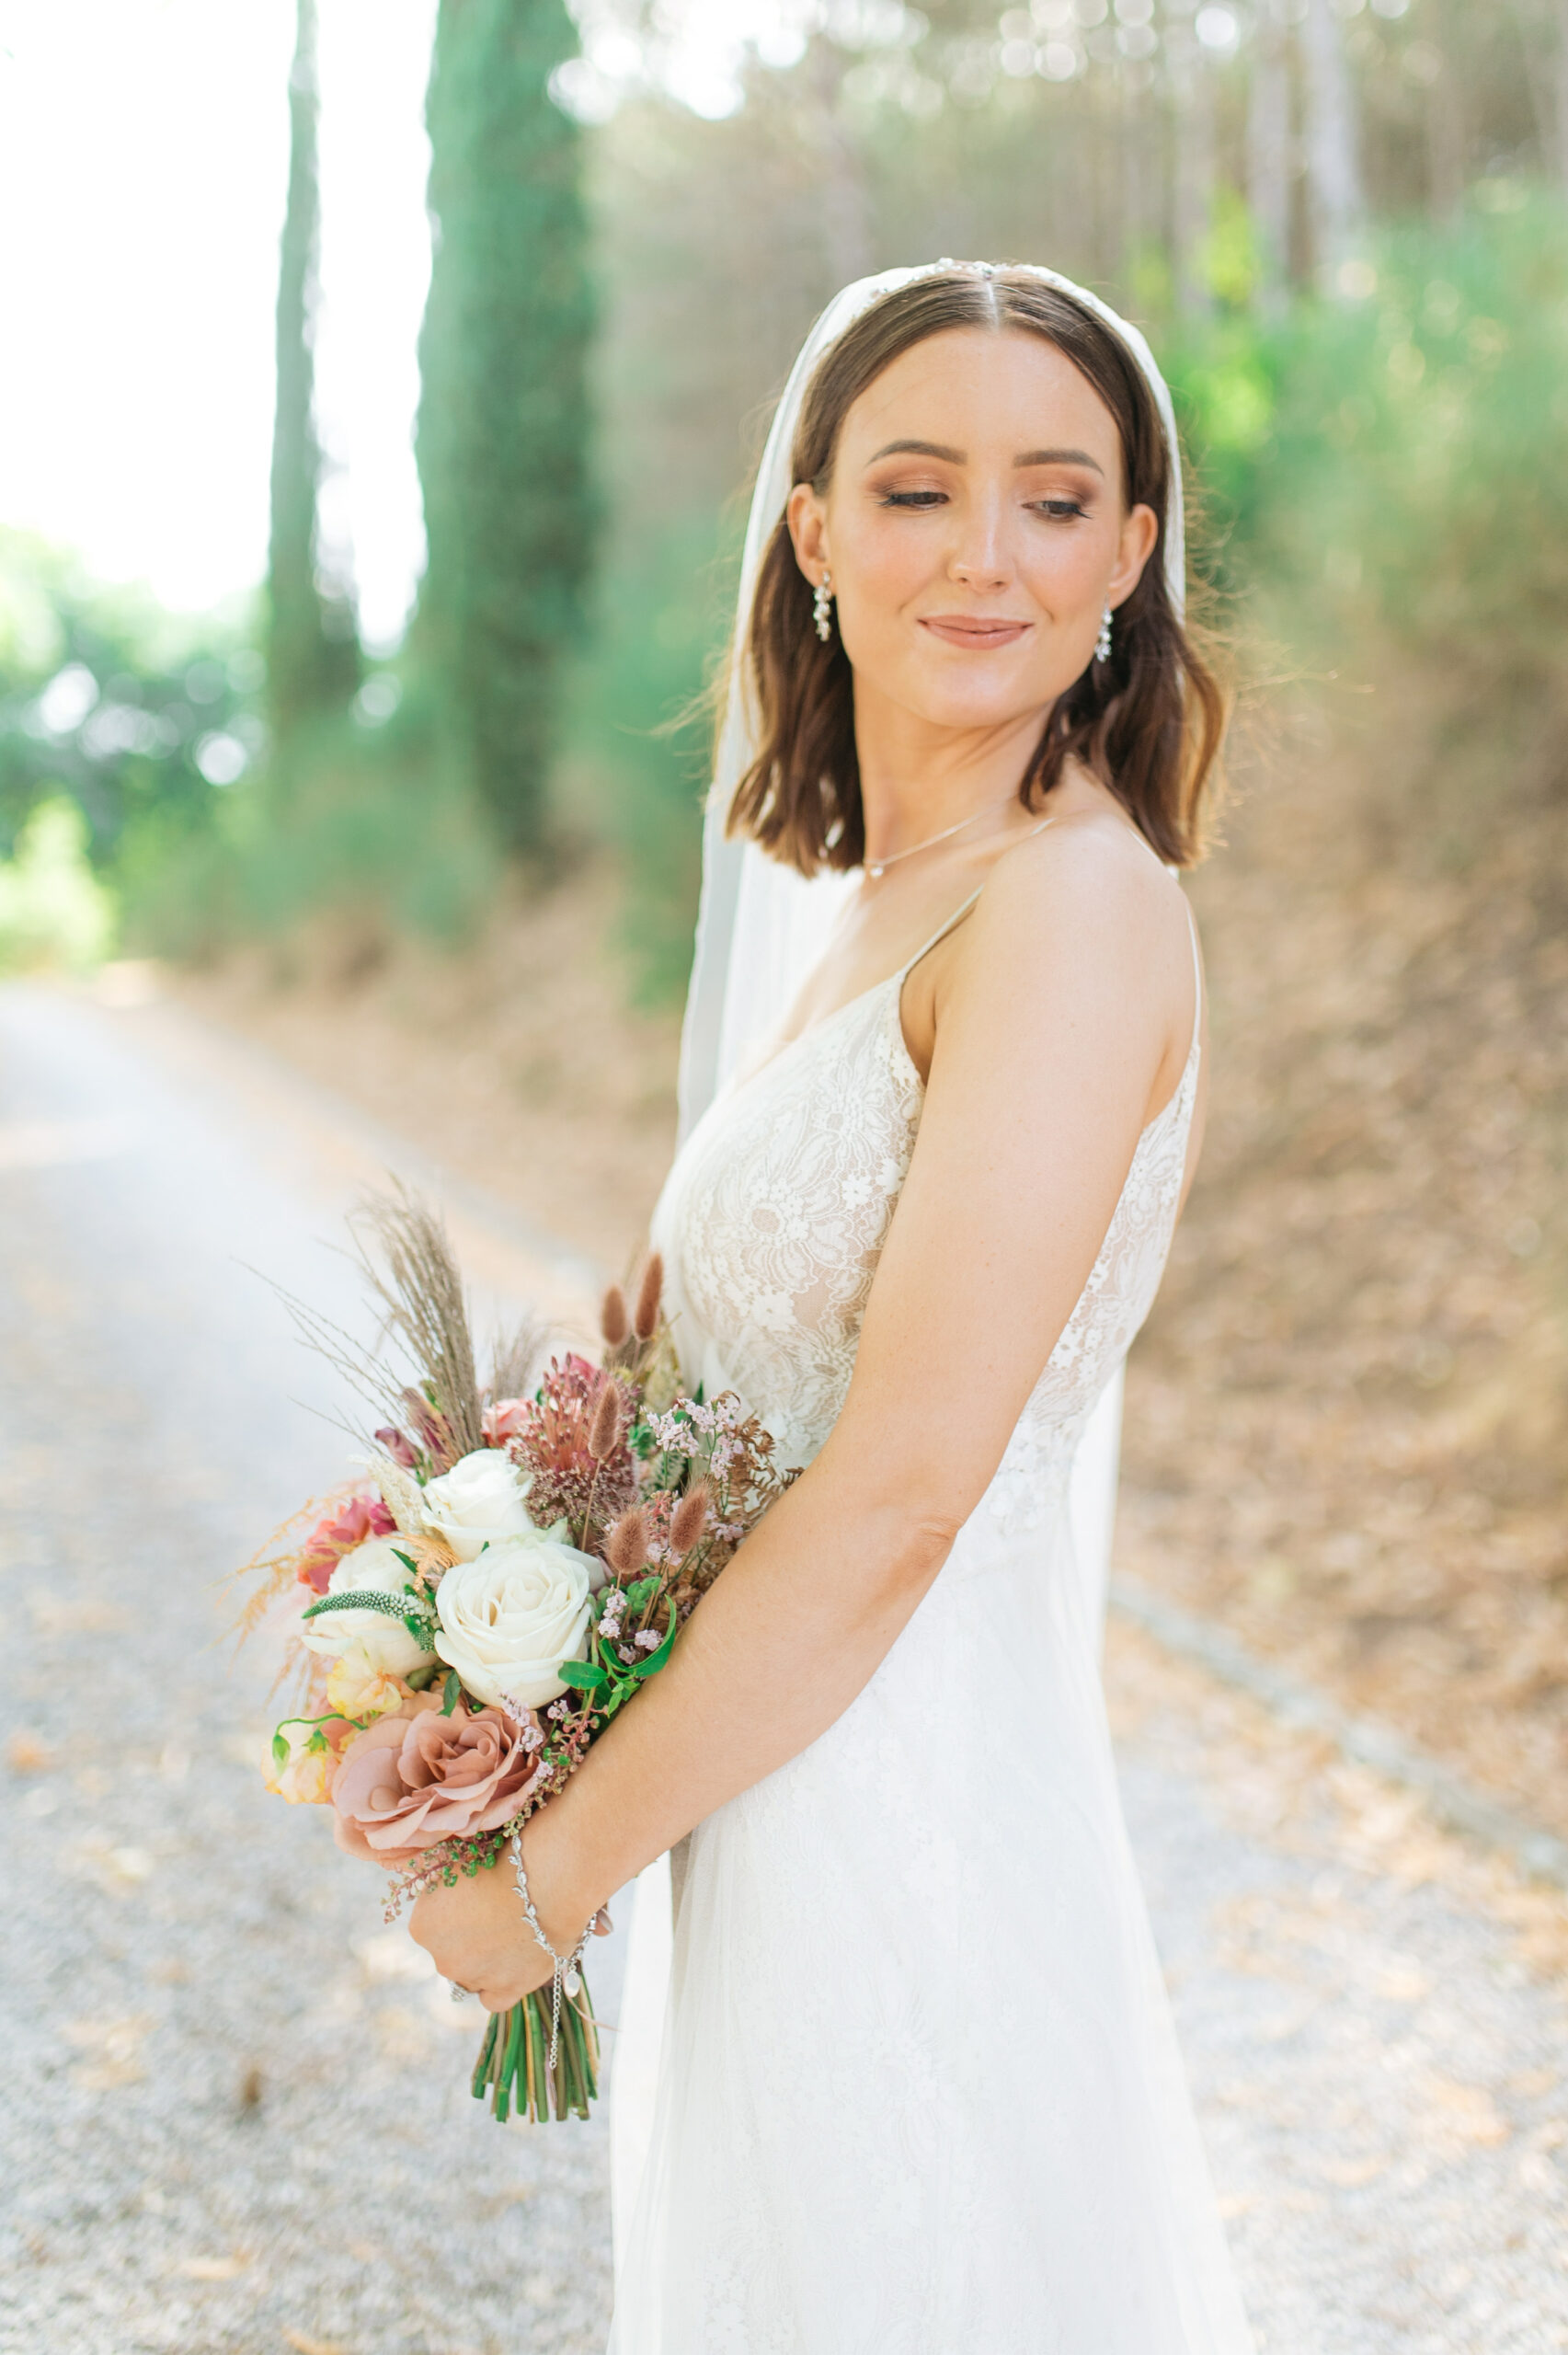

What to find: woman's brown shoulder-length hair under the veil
left=730, top=269, right=1227, bottom=876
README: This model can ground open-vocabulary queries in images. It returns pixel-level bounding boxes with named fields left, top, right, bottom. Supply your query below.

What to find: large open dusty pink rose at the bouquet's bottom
left=332, top=1694, right=542, bottom=1866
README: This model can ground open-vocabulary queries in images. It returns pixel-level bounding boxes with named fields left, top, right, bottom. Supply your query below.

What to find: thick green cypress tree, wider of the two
left=417, top=0, right=593, bottom=850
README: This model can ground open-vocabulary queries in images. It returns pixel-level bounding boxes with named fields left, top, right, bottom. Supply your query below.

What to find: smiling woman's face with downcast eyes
left=789, top=327, right=1159, bottom=728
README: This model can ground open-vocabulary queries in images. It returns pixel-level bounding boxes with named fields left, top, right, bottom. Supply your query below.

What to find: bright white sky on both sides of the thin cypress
left=0, top=0, right=436, bottom=640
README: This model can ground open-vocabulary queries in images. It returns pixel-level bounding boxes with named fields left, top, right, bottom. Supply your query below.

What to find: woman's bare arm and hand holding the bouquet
left=415, top=827, right=1191, bottom=2009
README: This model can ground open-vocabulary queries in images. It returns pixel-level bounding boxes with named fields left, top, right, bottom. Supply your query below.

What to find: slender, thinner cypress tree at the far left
left=266, top=0, right=358, bottom=763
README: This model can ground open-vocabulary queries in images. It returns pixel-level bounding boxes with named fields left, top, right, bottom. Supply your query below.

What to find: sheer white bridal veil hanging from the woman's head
left=612, top=261, right=1186, bottom=2246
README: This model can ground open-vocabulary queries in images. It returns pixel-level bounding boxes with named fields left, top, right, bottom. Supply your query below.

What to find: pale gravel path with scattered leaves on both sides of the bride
left=0, top=989, right=1568, bottom=2355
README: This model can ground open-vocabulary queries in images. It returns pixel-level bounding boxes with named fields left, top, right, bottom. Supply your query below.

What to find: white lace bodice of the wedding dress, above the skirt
left=652, top=912, right=1201, bottom=1528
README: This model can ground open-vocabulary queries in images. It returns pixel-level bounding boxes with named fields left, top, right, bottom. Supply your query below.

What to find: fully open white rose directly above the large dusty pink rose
left=436, top=1523, right=605, bottom=1710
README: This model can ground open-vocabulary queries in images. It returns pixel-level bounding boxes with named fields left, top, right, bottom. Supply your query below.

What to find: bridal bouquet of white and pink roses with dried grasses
left=240, top=1194, right=786, bottom=2120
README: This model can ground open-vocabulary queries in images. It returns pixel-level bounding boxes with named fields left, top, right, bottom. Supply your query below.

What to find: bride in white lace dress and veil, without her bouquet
left=415, top=261, right=1250, bottom=2355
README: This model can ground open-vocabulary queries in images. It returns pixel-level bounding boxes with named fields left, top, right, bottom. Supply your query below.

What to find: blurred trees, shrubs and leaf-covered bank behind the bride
left=0, top=0, right=1568, bottom=1830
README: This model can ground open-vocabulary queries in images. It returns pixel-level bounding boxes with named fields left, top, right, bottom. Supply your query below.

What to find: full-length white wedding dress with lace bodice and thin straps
left=610, top=890, right=1250, bottom=2355
